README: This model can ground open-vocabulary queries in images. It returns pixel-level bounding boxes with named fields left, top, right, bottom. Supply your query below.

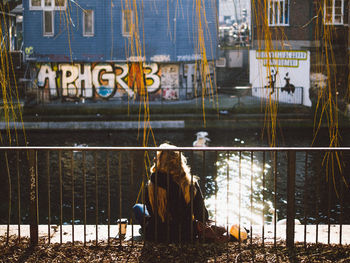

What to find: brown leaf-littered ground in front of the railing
left=0, top=236, right=350, bottom=263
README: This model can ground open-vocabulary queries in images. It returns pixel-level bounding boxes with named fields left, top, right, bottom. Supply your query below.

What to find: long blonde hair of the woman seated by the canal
left=148, top=143, right=197, bottom=222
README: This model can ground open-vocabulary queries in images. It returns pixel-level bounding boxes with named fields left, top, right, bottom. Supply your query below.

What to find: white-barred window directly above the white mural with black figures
left=268, top=0, right=289, bottom=26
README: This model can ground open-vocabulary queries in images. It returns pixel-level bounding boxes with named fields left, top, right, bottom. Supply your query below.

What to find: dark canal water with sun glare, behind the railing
left=0, top=129, right=350, bottom=225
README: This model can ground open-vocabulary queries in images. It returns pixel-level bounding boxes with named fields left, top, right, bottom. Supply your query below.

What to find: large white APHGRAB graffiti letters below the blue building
left=37, top=63, right=161, bottom=98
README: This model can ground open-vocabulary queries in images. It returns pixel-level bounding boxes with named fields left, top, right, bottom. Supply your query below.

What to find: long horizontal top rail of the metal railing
left=0, top=146, right=350, bottom=152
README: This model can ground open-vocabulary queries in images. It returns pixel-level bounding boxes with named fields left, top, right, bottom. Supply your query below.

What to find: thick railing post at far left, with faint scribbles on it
left=29, top=150, right=39, bottom=246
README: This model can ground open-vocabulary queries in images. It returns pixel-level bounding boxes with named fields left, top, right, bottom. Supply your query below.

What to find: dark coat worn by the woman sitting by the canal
left=145, top=173, right=208, bottom=242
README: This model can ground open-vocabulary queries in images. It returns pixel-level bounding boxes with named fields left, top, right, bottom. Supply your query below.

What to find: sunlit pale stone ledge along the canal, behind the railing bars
left=0, top=224, right=350, bottom=245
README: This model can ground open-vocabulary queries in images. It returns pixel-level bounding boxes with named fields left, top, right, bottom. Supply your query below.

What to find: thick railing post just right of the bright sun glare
left=286, top=151, right=296, bottom=249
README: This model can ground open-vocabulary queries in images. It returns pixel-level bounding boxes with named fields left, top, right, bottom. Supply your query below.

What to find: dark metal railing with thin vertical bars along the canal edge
left=0, top=147, right=350, bottom=250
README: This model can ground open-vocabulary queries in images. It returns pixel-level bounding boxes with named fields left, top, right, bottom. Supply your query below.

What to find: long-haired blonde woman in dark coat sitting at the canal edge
left=134, top=144, right=208, bottom=242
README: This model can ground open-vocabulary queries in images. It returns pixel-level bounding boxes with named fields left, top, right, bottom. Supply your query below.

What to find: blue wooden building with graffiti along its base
left=23, top=0, right=217, bottom=102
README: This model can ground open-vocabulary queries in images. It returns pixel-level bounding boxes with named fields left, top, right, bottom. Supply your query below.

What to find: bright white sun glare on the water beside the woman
left=206, top=152, right=273, bottom=225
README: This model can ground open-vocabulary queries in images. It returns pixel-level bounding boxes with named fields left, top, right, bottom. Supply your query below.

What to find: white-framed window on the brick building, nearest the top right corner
left=324, top=0, right=344, bottom=25
